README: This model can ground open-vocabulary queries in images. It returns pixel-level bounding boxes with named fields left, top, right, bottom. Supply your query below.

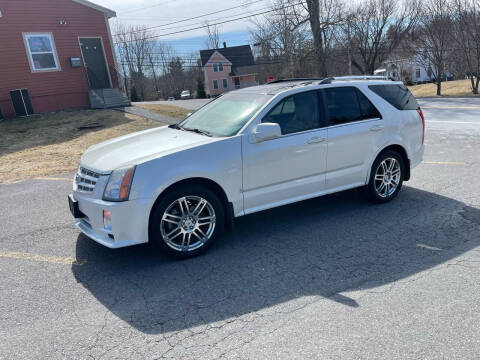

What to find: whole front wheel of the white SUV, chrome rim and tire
left=150, top=185, right=225, bottom=257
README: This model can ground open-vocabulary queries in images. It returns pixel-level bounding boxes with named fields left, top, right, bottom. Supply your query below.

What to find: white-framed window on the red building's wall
left=24, top=33, right=60, bottom=71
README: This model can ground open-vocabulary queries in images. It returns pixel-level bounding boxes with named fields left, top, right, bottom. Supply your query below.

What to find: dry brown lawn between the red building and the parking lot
left=0, top=110, right=162, bottom=183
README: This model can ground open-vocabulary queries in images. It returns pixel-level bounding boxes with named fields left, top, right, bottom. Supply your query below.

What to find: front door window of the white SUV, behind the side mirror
left=262, top=91, right=320, bottom=135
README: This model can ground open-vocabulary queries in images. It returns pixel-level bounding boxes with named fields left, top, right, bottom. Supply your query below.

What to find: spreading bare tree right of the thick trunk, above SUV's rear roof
left=344, top=0, right=419, bottom=74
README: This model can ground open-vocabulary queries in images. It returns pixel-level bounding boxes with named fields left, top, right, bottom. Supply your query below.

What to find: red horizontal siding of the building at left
left=0, top=0, right=118, bottom=117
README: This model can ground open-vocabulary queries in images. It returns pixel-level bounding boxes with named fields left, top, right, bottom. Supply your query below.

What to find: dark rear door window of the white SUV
left=324, top=87, right=363, bottom=125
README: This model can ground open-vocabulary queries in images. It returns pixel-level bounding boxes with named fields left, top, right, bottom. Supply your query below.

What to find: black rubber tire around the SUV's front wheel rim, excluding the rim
left=149, top=185, right=225, bottom=258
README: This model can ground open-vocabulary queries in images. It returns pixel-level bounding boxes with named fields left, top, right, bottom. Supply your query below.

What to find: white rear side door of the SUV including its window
left=323, top=87, right=384, bottom=191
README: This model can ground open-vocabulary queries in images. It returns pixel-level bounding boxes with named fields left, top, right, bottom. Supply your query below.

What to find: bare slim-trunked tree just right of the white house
left=417, top=0, right=453, bottom=95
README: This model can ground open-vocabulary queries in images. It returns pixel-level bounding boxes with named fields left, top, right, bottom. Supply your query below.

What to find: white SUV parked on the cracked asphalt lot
left=69, top=78, right=425, bottom=257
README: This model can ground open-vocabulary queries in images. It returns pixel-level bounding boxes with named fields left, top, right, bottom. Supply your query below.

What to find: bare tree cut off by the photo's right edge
left=452, top=0, right=480, bottom=94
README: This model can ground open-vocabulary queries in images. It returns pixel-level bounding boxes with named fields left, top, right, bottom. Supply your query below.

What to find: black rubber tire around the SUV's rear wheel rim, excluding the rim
left=364, top=150, right=405, bottom=204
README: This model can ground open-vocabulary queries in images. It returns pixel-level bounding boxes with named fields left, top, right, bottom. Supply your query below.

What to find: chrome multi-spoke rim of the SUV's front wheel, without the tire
left=160, top=196, right=216, bottom=252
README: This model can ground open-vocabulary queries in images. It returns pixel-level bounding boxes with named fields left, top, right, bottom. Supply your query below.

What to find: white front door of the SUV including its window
left=242, top=91, right=327, bottom=213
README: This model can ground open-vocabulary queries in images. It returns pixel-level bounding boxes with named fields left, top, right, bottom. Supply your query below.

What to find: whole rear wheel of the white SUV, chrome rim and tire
left=365, top=150, right=405, bottom=203
